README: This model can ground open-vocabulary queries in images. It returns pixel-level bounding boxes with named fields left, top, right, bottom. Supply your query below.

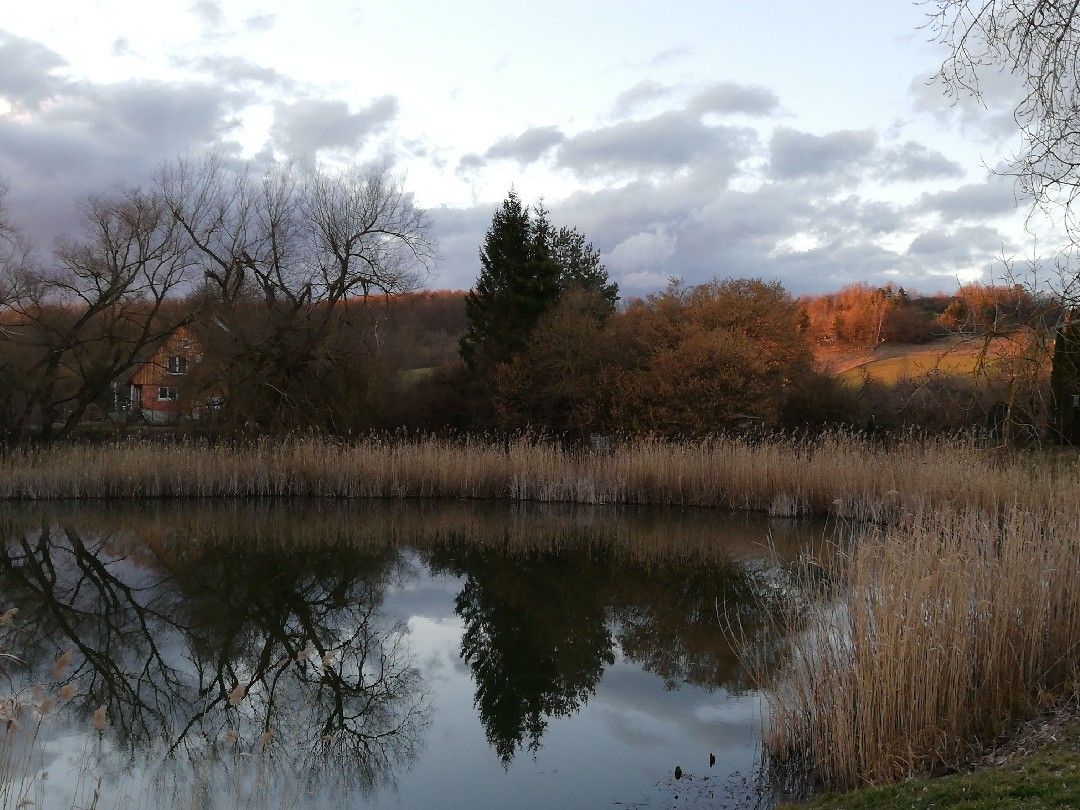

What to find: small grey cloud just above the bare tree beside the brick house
left=270, top=96, right=397, bottom=159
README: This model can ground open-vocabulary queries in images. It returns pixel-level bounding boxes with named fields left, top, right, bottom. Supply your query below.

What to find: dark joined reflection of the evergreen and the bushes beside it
left=429, top=544, right=790, bottom=766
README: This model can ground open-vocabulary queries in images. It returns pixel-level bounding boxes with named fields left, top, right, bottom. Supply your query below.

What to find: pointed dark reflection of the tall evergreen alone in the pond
left=435, top=551, right=615, bottom=765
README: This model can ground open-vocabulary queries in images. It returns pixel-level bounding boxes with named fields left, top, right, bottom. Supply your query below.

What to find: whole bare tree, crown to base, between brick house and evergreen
left=161, top=157, right=434, bottom=429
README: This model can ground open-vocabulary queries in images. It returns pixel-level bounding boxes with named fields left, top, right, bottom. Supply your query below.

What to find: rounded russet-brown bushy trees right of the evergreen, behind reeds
left=496, top=280, right=811, bottom=435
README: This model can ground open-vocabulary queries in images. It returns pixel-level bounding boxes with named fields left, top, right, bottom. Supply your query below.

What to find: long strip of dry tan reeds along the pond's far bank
left=0, top=435, right=1080, bottom=519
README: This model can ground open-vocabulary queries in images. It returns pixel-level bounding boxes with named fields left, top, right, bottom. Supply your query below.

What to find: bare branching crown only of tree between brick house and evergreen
left=161, top=156, right=434, bottom=307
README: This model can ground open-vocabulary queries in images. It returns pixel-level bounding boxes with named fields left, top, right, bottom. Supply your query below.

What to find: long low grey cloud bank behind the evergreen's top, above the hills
left=433, top=144, right=1008, bottom=296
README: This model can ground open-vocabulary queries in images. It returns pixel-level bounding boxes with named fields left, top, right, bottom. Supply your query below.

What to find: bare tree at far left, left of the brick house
left=8, top=189, right=190, bottom=438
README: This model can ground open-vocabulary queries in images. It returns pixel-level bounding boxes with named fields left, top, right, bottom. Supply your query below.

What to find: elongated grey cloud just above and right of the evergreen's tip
left=556, top=111, right=755, bottom=177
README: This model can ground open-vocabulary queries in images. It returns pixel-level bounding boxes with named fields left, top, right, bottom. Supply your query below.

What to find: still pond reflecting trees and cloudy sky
left=0, top=501, right=823, bottom=808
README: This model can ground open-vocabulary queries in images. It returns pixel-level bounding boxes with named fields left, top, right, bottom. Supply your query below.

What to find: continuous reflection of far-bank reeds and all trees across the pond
left=0, top=503, right=801, bottom=785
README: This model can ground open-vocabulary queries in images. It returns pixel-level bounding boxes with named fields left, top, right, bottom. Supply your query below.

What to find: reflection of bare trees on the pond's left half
left=0, top=525, right=427, bottom=803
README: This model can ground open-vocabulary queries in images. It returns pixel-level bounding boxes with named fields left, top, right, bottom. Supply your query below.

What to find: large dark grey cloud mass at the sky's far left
left=0, top=30, right=246, bottom=249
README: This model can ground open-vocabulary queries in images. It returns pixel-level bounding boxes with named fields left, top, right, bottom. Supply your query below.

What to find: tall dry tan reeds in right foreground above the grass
left=762, top=502, right=1080, bottom=789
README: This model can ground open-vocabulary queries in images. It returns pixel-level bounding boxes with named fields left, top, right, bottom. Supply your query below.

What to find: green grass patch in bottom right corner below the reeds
left=788, top=725, right=1080, bottom=810
